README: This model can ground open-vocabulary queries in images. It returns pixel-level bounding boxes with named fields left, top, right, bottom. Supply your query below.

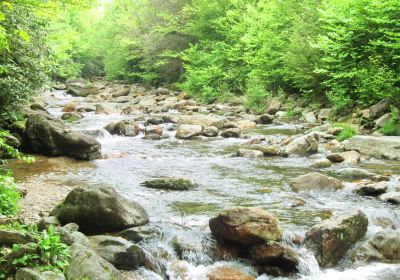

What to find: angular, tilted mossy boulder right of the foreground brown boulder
left=305, top=210, right=368, bottom=267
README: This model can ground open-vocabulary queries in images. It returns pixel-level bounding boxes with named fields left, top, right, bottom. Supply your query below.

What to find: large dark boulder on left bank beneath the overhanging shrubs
left=26, top=114, right=101, bottom=160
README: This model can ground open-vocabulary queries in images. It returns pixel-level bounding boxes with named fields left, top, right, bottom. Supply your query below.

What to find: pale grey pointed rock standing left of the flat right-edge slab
left=284, top=132, right=319, bottom=155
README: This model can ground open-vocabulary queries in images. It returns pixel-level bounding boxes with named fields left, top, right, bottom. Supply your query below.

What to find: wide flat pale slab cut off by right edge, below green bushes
left=342, top=135, right=400, bottom=160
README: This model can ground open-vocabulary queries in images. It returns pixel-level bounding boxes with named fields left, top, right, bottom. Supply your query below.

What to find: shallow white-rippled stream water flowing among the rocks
left=8, top=91, right=400, bottom=280
